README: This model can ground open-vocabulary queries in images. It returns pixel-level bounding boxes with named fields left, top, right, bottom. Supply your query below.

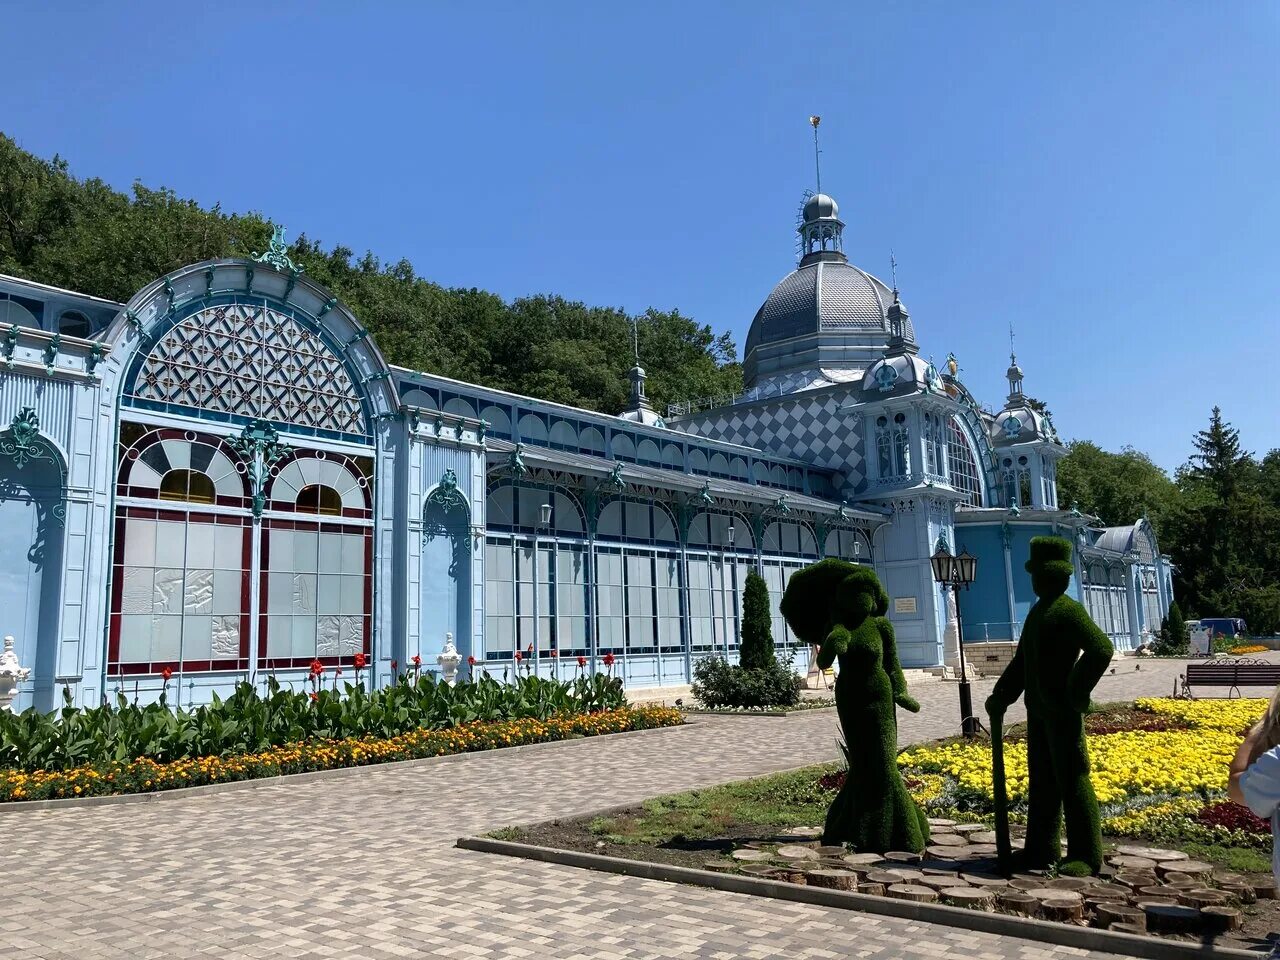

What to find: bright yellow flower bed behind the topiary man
left=899, top=698, right=1271, bottom=847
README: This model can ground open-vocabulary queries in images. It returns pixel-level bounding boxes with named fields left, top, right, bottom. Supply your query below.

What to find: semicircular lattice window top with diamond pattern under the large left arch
left=133, top=303, right=367, bottom=434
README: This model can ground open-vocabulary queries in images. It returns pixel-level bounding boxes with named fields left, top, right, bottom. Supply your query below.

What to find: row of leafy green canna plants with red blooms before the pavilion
left=0, top=673, right=626, bottom=771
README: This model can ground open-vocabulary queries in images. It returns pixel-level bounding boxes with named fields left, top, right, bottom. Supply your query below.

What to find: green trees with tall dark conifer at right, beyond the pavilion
left=1057, top=407, right=1280, bottom=634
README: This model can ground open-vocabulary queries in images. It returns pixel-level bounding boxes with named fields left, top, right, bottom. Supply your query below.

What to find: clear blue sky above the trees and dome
left=0, top=0, right=1280, bottom=467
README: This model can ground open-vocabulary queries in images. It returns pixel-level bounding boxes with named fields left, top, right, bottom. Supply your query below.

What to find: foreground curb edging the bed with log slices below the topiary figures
left=457, top=837, right=1262, bottom=960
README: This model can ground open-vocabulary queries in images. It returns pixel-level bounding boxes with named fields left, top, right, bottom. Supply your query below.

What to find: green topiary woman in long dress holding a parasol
left=782, top=558, right=929, bottom=854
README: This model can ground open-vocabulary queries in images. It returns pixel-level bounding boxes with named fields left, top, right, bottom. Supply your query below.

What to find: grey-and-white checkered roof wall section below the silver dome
left=675, top=390, right=863, bottom=486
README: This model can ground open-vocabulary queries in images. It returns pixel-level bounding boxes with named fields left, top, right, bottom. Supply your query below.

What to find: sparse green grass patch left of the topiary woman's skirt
left=590, top=764, right=837, bottom=845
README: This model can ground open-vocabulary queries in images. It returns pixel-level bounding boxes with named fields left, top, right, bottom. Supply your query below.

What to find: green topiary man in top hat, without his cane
left=987, top=536, right=1115, bottom=874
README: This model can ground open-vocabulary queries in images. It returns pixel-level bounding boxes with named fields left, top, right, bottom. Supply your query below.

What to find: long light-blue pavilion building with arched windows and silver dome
left=0, top=195, right=1170, bottom=709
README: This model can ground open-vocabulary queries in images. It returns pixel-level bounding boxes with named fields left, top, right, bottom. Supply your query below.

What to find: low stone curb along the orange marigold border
left=0, top=719, right=698, bottom=817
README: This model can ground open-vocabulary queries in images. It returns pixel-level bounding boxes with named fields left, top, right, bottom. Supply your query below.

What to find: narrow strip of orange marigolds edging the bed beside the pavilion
left=0, top=707, right=684, bottom=803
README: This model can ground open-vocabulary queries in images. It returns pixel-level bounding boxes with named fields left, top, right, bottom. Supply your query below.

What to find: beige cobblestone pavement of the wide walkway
left=0, top=663, right=1239, bottom=960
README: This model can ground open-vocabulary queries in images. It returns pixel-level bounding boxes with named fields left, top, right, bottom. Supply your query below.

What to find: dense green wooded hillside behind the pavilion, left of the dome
left=0, top=134, right=741, bottom=413
